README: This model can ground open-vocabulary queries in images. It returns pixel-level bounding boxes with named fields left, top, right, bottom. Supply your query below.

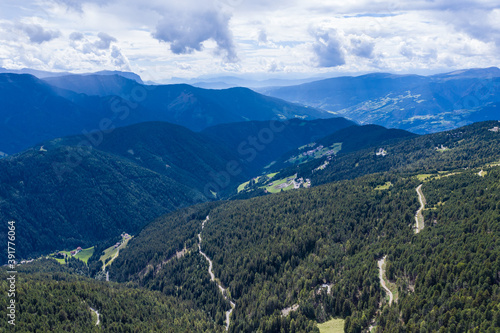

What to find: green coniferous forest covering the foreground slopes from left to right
left=2, top=118, right=500, bottom=332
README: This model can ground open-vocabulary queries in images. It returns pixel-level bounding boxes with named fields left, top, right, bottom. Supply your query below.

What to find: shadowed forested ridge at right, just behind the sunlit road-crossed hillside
left=283, top=121, right=500, bottom=185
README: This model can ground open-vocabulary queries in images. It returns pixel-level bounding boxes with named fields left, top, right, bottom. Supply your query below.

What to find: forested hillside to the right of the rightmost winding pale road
left=377, top=167, right=500, bottom=332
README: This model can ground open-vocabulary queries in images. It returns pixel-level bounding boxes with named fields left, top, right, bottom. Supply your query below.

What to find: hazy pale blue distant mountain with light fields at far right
left=259, top=68, right=500, bottom=134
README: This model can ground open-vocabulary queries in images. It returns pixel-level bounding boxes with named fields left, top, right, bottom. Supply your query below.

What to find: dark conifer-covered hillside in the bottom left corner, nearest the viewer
left=0, top=260, right=223, bottom=333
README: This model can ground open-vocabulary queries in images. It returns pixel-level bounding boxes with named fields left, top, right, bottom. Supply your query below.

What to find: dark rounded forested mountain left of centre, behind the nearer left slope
left=44, top=122, right=248, bottom=197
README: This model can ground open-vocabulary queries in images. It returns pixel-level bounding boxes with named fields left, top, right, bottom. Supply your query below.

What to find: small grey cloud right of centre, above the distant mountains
left=310, top=29, right=345, bottom=67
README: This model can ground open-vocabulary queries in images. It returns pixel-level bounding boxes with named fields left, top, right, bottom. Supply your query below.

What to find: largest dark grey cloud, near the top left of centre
left=152, top=9, right=238, bottom=62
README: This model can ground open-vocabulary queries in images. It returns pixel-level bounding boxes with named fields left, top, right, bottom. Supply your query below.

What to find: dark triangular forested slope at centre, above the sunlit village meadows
left=201, top=118, right=354, bottom=175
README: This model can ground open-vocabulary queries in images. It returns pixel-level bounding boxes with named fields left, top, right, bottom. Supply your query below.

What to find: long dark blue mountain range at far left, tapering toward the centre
left=0, top=74, right=328, bottom=155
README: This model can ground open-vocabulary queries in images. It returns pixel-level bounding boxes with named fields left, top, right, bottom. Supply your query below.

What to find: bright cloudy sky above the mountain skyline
left=0, top=0, right=500, bottom=82
